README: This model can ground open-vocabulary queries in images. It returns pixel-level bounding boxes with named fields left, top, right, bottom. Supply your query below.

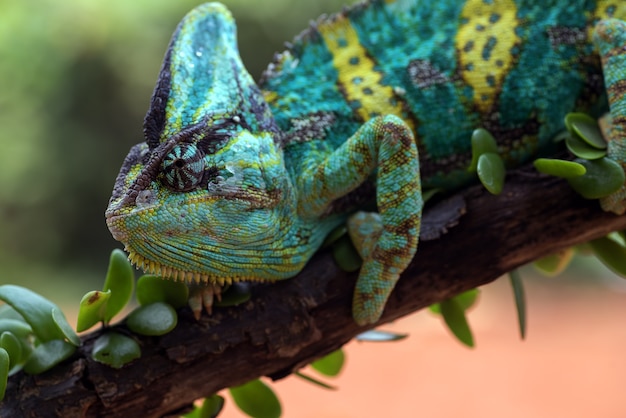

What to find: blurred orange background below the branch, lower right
left=220, top=266, right=626, bottom=418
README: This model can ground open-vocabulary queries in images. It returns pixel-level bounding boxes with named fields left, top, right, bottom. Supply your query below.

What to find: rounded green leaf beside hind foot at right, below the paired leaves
left=567, top=158, right=625, bottom=199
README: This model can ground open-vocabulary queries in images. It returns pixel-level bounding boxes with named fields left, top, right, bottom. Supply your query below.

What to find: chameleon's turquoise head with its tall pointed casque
left=106, top=4, right=305, bottom=284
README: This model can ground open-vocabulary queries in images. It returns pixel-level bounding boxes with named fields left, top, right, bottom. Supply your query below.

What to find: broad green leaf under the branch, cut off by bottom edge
left=229, top=379, right=282, bottom=418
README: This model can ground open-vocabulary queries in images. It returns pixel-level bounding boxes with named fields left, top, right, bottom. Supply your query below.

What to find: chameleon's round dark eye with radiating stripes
left=161, top=144, right=204, bottom=192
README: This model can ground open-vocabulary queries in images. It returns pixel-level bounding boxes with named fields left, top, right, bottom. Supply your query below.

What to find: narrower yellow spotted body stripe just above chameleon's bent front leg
left=317, top=16, right=414, bottom=130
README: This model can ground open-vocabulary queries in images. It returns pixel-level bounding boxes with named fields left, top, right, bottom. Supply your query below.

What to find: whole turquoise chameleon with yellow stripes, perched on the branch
left=106, top=0, right=626, bottom=324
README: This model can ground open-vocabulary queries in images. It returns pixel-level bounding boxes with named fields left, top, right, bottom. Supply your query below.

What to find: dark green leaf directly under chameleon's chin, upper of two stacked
left=136, top=274, right=189, bottom=309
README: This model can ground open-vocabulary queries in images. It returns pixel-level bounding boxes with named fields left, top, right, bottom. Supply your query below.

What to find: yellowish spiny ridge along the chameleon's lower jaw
left=124, top=248, right=267, bottom=286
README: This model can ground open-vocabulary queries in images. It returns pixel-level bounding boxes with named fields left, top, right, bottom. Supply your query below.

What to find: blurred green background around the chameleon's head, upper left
left=0, top=0, right=352, bottom=305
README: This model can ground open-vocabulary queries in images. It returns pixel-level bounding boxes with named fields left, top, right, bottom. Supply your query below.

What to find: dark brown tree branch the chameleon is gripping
left=0, top=171, right=626, bottom=417
